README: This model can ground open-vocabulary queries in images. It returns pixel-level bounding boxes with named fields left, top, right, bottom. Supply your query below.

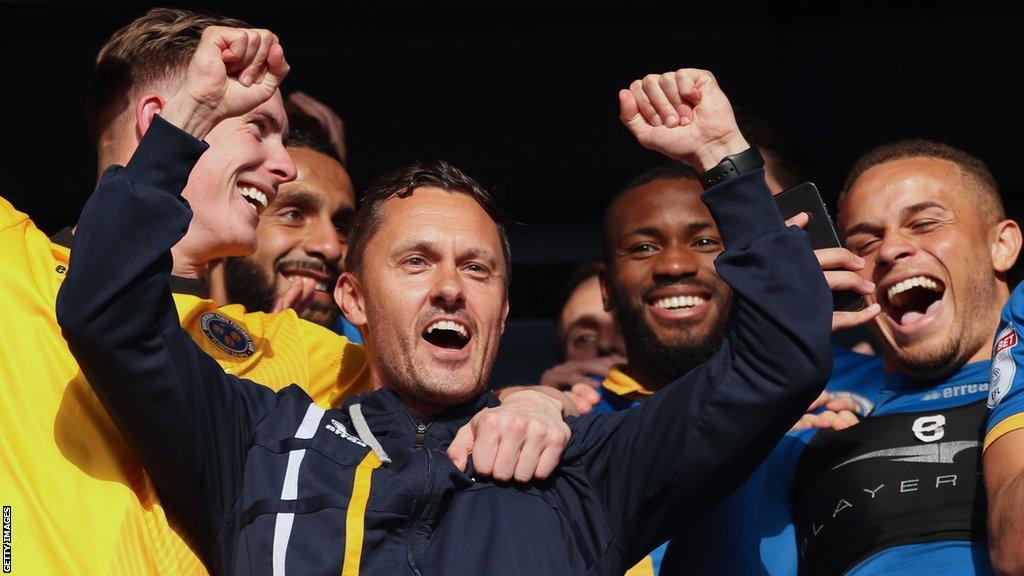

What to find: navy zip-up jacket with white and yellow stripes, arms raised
left=57, top=118, right=831, bottom=576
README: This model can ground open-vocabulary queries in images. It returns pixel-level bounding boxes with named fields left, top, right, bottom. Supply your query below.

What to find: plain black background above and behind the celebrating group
left=0, top=0, right=1024, bottom=382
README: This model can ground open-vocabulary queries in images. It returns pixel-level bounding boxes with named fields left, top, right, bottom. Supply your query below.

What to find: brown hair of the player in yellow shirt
left=86, top=8, right=249, bottom=143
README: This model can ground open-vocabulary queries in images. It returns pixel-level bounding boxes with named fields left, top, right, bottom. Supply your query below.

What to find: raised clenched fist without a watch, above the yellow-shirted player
left=161, top=26, right=289, bottom=138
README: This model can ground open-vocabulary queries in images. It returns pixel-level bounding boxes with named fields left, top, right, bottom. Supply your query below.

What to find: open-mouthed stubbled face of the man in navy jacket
left=336, top=188, right=508, bottom=416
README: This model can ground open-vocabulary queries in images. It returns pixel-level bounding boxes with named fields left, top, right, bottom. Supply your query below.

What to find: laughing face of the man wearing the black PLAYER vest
left=840, top=158, right=1016, bottom=378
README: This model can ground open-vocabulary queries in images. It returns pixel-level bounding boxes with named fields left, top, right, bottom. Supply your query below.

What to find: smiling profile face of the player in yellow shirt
left=181, top=93, right=295, bottom=259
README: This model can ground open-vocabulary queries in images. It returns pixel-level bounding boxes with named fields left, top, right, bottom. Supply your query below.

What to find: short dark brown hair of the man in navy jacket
left=345, top=160, right=512, bottom=288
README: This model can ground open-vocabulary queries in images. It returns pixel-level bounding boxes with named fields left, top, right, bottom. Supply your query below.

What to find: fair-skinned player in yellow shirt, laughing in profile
left=0, top=9, right=368, bottom=576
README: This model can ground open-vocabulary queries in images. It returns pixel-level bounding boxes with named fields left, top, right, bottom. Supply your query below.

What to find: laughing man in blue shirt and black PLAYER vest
left=761, top=140, right=1021, bottom=575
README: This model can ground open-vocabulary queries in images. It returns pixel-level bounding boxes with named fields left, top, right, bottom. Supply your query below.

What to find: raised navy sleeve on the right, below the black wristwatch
left=564, top=170, right=831, bottom=563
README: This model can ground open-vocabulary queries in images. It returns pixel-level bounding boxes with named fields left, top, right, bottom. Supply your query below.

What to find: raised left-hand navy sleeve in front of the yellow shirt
left=56, top=117, right=276, bottom=560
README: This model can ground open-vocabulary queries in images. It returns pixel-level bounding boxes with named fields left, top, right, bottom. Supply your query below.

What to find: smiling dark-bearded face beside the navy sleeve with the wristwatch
left=602, top=179, right=732, bottom=387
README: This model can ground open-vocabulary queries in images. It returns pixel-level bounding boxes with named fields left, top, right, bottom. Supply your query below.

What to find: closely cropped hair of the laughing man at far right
left=837, top=139, right=1007, bottom=223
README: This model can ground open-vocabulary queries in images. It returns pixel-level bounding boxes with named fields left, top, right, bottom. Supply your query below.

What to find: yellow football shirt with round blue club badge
left=0, top=198, right=369, bottom=576
